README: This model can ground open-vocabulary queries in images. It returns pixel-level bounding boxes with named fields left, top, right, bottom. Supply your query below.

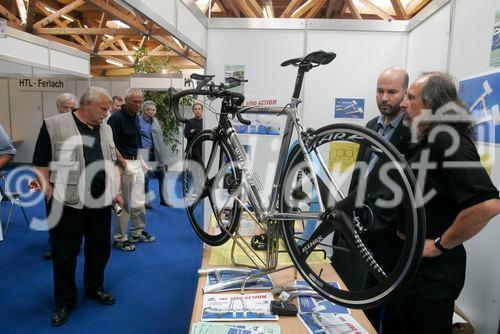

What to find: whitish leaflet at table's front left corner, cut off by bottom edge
left=191, top=322, right=281, bottom=334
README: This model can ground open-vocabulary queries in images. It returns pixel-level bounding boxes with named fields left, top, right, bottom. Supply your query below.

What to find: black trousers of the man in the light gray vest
left=49, top=200, right=111, bottom=307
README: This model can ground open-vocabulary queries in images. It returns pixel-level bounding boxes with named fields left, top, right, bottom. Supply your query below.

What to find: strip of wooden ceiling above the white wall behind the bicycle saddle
left=195, top=0, right=432, bottom=21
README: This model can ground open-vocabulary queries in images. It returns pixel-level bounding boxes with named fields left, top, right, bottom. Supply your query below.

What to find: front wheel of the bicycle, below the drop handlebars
left=182, top=130, right=242, bottom=246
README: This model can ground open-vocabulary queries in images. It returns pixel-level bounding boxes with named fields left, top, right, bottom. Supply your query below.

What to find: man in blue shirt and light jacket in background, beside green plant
left=139, top=101, right=169, bottom=208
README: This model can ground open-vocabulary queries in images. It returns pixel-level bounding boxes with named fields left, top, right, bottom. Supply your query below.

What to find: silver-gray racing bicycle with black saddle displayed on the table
left=171, top=51, right=425, bottom=308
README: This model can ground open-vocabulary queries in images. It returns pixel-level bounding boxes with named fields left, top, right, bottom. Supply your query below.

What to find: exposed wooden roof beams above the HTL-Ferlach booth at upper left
left=0, top=0, right=205, bottom=76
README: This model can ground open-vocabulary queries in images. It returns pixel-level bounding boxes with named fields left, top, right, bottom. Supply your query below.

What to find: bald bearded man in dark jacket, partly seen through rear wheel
left=332, top=67, right=410, bottom=329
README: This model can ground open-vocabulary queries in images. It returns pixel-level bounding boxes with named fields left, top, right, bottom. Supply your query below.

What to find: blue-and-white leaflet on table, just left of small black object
left=201, top=292, right=278, bottom=321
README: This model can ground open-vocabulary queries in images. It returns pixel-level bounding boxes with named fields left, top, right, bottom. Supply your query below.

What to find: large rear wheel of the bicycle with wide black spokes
left=279, top=124, right=425, bottom=308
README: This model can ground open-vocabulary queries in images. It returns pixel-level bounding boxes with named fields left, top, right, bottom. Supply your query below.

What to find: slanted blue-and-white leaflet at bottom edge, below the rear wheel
left=299, top=313, right=368, bottom=334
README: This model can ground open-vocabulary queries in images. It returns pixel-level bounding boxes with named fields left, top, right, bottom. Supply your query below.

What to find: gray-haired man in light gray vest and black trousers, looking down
left=33, top=87, right=123, bottom=326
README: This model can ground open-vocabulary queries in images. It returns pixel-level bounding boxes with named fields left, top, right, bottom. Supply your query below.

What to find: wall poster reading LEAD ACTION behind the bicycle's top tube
left=231, top=95, right=286, bottom=136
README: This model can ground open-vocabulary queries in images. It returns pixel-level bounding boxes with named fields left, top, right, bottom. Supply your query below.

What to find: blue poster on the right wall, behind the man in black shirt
left=458, top=71, right=500, bottom=144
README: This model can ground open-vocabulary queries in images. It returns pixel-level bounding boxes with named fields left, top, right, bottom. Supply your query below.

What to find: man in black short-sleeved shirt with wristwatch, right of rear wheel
left=383, top=72, right=500, bottom=334
